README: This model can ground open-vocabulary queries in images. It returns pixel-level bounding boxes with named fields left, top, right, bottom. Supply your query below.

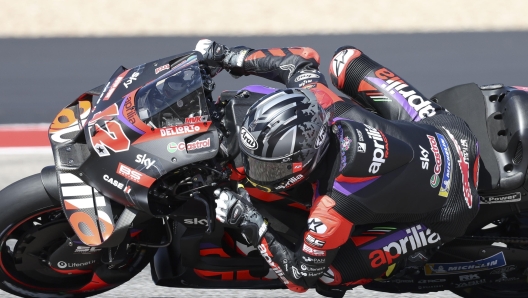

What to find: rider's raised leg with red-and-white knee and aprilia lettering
left=330, top=46, right=445, bottom=121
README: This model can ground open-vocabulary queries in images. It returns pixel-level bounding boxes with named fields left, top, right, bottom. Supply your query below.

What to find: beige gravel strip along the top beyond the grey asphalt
left=0, top=0, right=528, bottom=37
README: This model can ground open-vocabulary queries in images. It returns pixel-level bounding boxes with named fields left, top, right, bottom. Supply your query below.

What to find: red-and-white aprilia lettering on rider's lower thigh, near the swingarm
left=369, top=225, right=440, bottom=268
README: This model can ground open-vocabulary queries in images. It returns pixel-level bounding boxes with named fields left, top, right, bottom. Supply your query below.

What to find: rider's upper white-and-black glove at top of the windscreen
left=195, top=39, right=252, bottom=76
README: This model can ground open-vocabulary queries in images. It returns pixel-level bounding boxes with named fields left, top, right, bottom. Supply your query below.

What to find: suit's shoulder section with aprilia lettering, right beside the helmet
left=333, top=119, right=414, bottom=177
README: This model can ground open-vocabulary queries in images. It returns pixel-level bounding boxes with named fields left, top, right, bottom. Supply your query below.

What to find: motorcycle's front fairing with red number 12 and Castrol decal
left=49, top=52, right=219, bottom=247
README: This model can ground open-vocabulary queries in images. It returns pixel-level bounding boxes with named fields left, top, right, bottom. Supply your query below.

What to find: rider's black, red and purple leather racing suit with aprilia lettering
left=228, top=46, right=479, bottom=292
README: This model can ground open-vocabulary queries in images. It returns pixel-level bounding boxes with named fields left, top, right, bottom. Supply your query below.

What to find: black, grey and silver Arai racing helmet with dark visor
left=239, top=89, right=330, bottom=192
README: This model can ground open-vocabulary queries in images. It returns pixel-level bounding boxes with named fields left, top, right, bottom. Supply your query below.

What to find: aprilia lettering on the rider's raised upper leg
left=367, top=68, right=436, bottom=120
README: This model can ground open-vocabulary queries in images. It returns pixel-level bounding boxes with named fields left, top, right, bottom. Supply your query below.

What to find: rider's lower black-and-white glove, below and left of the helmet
left=215, top=188, right=268, bottom=247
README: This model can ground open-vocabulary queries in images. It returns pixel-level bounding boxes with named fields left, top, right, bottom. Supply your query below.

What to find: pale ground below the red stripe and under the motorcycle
left=0, top=152, right=458, bottom=298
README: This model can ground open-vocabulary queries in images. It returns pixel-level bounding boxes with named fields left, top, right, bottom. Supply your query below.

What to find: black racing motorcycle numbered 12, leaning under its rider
left=0, top=52, right=528, bottom=297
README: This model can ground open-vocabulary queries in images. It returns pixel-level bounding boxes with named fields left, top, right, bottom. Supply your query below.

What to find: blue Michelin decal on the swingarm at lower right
left=424, top=252, right=506, bottom=275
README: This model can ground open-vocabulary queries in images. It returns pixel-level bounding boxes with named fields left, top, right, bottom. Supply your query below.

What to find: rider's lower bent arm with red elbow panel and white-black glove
left=215, top=188, right=353, bottom=292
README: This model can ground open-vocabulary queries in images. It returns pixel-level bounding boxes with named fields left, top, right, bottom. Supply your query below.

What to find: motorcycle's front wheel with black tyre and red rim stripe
left=0, top=174, right=155, bottom=297
